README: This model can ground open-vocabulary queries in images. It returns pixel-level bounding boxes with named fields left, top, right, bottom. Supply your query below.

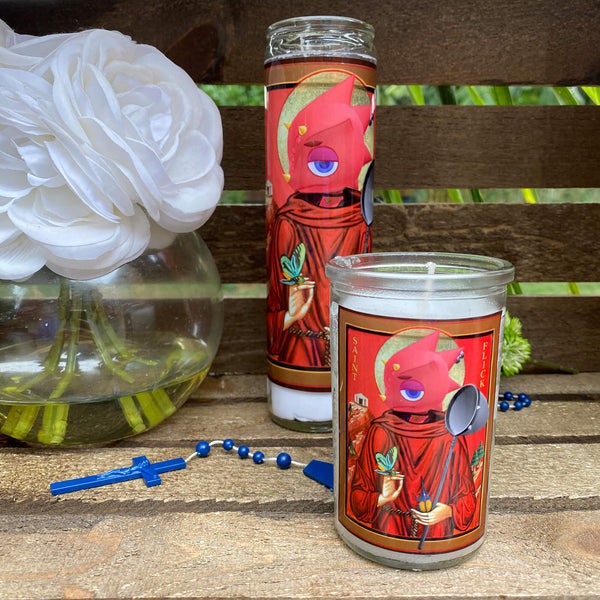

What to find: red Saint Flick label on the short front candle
left=338, top=307, right=502, bottom=554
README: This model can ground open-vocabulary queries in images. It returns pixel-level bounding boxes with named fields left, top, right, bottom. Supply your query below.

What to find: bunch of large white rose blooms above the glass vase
left=0, top=20, right=223, bottom=279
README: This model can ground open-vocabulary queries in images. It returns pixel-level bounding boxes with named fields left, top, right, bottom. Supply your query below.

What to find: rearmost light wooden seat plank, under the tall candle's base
left=0, top=373, right=600, bottom=453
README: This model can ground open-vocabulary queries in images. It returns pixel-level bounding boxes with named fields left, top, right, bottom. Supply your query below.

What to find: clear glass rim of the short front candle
left=326, top=252, right=515, bottom=291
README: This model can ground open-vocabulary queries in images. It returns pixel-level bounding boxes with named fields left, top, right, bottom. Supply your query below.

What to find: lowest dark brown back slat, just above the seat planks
left=212, top=296, right=600, bottom=374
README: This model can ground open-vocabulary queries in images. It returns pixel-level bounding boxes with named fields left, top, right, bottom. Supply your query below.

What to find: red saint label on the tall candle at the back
left=265, top=59, right=375, bottom=391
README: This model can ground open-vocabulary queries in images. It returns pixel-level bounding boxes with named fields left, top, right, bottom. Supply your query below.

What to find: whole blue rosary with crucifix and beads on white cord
left=50, top=392, right=531, bottom=496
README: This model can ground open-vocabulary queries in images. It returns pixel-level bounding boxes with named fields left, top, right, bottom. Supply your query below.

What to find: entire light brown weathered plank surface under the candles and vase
left=0, top=374, right=600, bottom=600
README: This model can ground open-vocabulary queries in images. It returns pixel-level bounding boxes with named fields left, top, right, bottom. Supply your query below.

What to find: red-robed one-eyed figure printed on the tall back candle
left=267, top=76, right=372, bottom=376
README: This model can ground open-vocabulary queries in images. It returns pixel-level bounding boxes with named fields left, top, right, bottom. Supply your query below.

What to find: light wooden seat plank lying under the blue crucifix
left=0, top=443, right=600, bottom=515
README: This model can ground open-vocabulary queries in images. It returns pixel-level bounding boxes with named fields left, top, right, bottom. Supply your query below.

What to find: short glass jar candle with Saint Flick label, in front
left=326, top=253, right=514, bottom=570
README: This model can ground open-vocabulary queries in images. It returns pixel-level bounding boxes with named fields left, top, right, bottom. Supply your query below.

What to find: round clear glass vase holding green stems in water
left=0, top=233, right=223, bottom=446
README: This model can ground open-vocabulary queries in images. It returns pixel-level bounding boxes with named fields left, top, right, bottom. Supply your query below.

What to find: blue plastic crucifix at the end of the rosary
left=50, top=456, right=187, bottom=496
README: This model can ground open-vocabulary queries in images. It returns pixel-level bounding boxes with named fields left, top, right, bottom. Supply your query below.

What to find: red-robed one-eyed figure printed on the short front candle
left=349, top=331, right=477, bottom=539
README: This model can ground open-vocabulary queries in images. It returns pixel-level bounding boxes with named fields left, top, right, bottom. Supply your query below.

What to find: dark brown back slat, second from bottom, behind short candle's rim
left=200, top=204, right=600, bottom=283
